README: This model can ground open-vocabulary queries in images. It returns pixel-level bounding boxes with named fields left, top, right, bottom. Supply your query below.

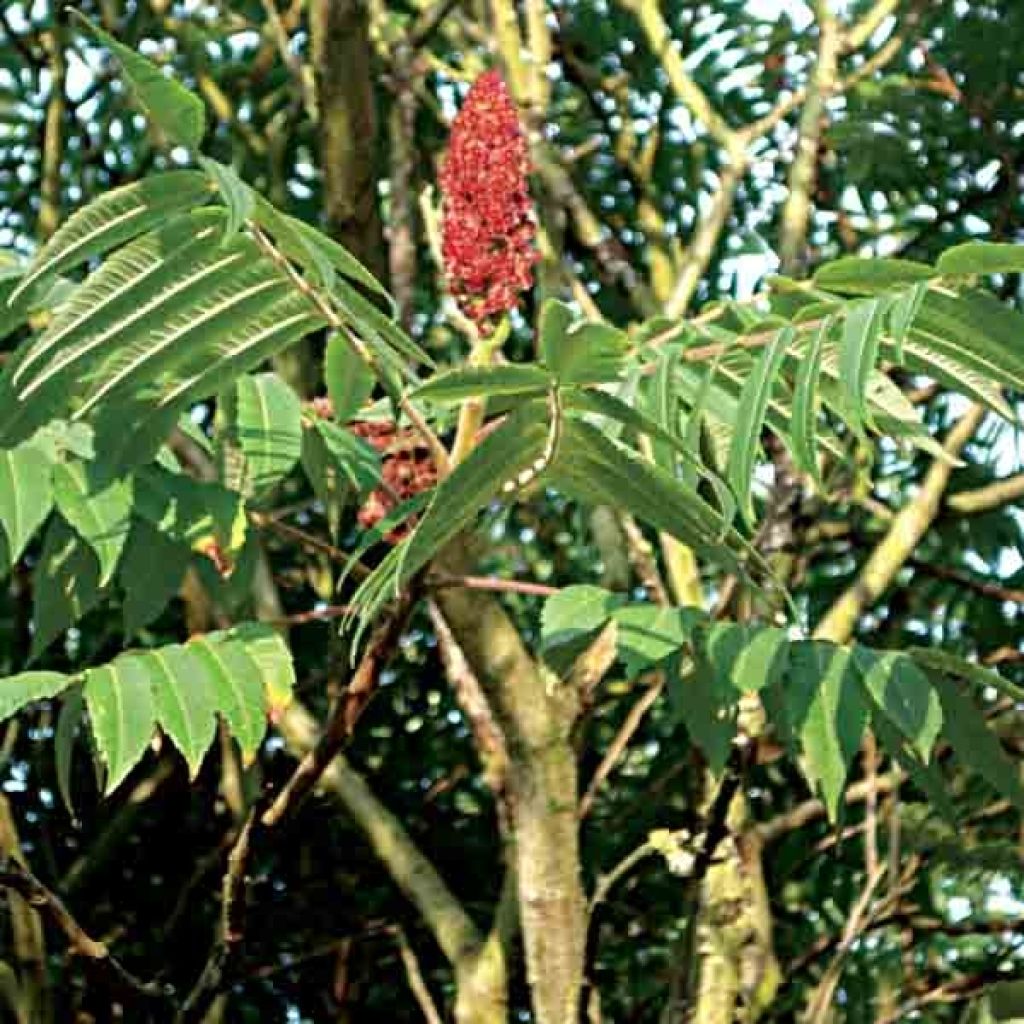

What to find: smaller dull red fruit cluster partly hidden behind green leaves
left=350, top=420, right=437, bottom=544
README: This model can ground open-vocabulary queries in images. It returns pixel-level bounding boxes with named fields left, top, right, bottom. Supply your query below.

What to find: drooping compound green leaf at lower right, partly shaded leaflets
left=541, top=586, right=1024, bottom=819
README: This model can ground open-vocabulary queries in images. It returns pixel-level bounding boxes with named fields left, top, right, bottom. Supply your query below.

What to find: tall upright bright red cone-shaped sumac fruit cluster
left=440, top=71, right=539, bottom=334
